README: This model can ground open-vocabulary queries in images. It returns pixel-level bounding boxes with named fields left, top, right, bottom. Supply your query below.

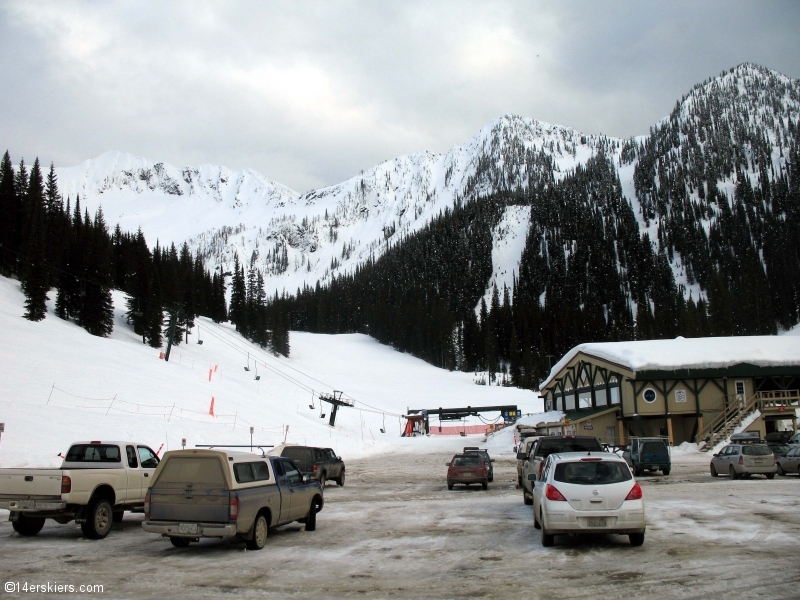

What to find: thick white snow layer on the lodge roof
left=539, top=335, right=800, bottom=390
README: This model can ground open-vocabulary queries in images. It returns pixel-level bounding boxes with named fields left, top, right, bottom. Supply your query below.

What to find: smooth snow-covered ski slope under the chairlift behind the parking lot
left=0, top=277, right=542, bottom=467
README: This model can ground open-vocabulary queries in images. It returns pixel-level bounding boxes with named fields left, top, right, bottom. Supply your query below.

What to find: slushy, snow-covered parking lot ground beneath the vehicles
left=0, top=438, right=800, bottom=599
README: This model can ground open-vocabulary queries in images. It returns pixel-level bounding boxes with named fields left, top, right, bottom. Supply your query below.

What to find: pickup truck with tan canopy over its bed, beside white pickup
left=142, top=450, right=323, bottom=550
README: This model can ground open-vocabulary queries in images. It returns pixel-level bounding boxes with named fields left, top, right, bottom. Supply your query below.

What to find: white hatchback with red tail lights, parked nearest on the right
left=528, top=452, right=647, bottom=546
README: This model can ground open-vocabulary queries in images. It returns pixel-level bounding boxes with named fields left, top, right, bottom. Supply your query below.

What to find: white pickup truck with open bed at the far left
left=0, top=441, right=158, bottom=539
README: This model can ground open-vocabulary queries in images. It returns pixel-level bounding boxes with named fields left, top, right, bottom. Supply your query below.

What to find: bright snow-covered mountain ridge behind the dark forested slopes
left=57, top=115, right=622, bottom=293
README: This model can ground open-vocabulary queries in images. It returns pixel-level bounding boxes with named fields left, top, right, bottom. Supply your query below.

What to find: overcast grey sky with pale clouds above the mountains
left=0, top=0, right=800, bottom=192
